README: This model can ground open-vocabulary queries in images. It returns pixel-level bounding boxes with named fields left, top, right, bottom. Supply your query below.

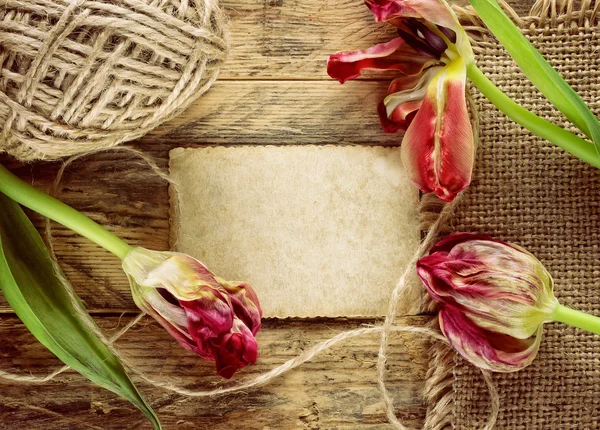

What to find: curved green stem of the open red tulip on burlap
left=467, top=63, right=600, bottom=169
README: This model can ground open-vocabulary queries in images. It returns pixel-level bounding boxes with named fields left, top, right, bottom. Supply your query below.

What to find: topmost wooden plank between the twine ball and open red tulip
left=221, top=0, right=533, bottom=80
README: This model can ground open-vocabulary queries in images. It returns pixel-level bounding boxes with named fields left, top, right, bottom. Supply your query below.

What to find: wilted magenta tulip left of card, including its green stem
left=0, top=165, right=262, bottom=378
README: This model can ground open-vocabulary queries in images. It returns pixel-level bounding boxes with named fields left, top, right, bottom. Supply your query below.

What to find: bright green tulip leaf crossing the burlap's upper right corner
left=469, top=0, right=600, bottom=161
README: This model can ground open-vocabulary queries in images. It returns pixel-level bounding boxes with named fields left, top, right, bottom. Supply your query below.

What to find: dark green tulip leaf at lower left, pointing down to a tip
left=0, top=193, right=161, bottom=429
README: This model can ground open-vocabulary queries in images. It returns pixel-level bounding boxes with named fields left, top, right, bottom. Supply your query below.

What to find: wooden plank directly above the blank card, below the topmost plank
left=140, top=80, right=401, bottom=146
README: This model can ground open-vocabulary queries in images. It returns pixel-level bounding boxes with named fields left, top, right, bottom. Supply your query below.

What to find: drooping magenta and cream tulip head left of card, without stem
left=123, top=248, right=262, bottom=378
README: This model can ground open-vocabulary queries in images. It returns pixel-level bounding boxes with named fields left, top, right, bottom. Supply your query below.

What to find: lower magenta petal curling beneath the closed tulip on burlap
left=439, top=306, right=543, bottom=372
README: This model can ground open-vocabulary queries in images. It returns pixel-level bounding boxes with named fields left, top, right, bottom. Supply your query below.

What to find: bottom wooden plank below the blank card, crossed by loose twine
left=0, top=317, right=428, bottom=430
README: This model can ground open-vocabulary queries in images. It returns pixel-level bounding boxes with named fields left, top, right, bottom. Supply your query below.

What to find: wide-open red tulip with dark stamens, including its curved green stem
left=327, top=0, right=600, bottom=201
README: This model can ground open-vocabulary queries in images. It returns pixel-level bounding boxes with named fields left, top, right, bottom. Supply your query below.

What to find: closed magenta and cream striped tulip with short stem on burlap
left=417, top=233, right=600, bottom=372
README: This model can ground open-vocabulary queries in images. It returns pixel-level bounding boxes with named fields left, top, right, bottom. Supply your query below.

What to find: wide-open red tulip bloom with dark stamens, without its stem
left=327, top=0, right=474, bottom=201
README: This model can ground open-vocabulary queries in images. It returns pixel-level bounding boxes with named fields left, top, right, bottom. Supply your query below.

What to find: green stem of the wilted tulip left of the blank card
left=0, top=165, right=132, bottom=260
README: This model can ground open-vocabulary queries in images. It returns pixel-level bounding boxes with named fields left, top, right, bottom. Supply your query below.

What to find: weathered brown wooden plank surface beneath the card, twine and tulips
left=0, top=0, right=528, bottom=429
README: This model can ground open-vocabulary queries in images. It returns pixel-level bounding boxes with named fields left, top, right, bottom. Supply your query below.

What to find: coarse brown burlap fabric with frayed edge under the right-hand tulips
left=426, top=2, right=600, bottom=430
